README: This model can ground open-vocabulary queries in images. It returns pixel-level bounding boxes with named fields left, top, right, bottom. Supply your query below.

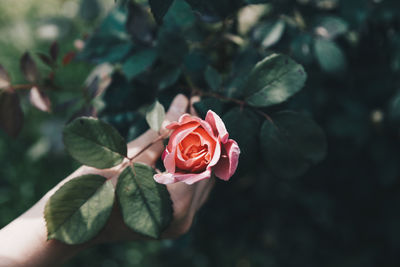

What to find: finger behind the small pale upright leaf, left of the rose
left=128, top=94, right=189, bottom=165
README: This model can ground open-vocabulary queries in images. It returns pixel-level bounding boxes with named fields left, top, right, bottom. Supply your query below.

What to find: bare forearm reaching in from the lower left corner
left=0, top=167, right=101, bottom=267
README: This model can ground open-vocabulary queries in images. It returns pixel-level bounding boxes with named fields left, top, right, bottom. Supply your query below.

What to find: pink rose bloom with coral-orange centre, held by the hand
left=154, top=110, right=240, bottom=184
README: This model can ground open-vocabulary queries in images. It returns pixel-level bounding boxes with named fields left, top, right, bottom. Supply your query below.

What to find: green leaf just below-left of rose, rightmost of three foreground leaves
left=116, top=163, right=173, bottom=238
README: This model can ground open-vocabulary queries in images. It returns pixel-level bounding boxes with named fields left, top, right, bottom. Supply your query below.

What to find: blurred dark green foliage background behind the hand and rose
left=0, top=0, right=400, bottom=267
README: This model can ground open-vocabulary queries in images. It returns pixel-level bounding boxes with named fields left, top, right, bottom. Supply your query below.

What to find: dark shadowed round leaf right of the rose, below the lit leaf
left=260, top=111, right=326, bottom=178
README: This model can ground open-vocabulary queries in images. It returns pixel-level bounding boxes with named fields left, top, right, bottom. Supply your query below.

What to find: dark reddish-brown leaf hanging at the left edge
left=0, top=90, right=24, bottom=137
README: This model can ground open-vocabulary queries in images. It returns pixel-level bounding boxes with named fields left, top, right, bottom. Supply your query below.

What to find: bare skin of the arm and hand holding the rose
left=0, top=95, right=214, bottom=267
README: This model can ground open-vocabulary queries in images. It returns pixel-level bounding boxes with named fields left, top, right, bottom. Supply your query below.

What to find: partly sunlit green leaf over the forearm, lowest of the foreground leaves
left=44, top=174, right=114, bottom=245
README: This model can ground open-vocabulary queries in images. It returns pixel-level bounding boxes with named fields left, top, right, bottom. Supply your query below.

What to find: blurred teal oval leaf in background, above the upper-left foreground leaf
left=122, top=48, right=157, bottom=80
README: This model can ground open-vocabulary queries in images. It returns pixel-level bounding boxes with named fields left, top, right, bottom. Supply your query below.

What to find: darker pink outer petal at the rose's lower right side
left=214, top=139, right=240, bottom=181
